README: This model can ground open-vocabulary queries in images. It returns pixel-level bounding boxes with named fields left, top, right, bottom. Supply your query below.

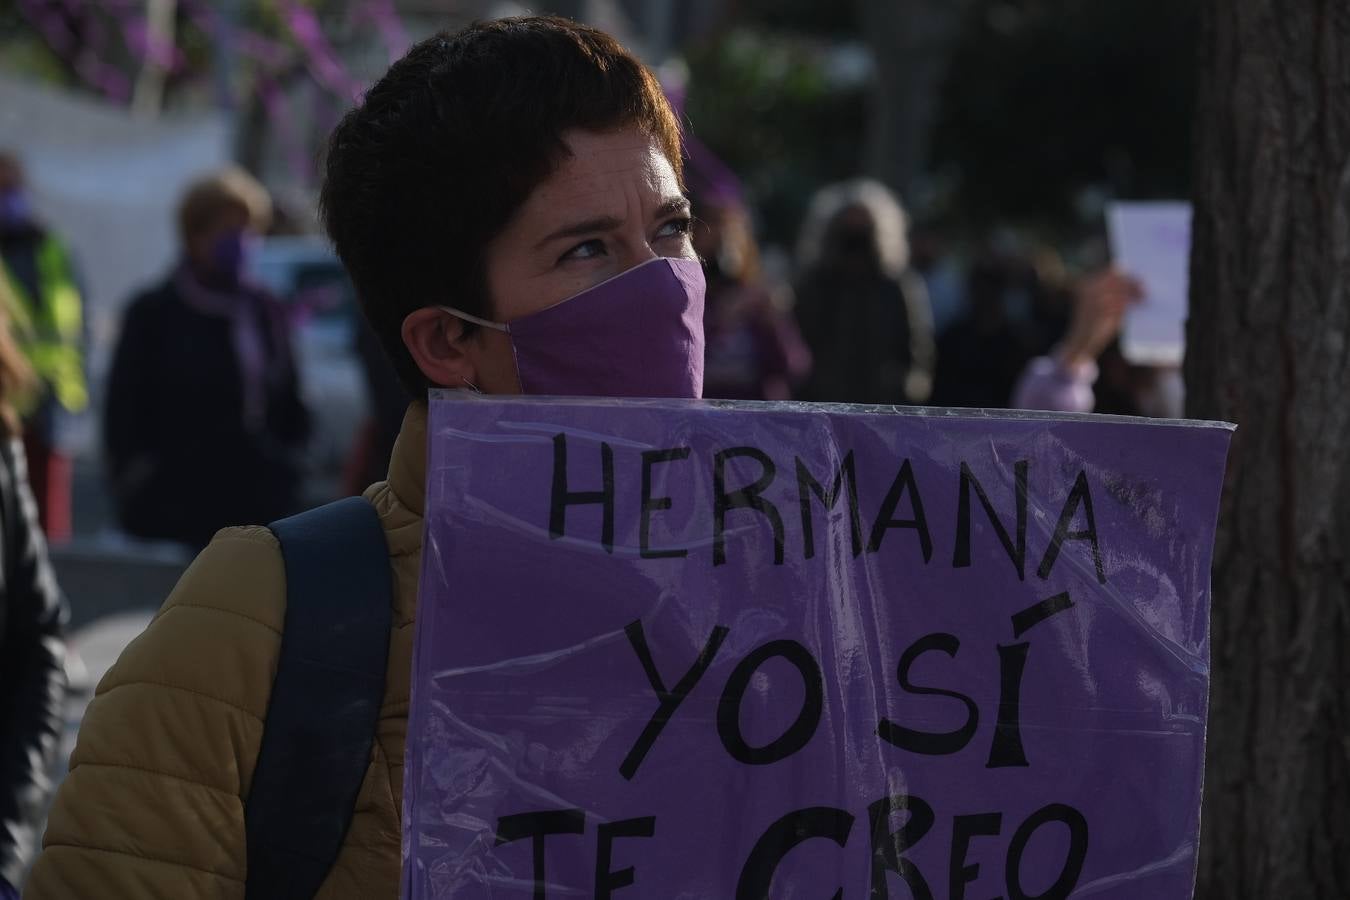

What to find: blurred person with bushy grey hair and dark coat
left=797, top=179, right=934, bottom=403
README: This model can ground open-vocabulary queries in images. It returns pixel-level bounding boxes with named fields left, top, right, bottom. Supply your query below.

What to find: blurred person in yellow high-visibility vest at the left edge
left=0, top=151, right=89, bottom=541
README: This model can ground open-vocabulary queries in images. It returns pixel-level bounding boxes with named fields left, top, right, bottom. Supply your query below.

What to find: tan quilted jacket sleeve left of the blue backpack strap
left=24, top=528, right=285, bottom=900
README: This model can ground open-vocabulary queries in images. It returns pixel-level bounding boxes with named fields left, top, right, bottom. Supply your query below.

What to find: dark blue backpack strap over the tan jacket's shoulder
left=244, top=497, right=393, bottom=900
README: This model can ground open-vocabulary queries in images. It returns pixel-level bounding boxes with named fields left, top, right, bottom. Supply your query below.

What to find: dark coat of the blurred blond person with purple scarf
left=103, top=278, right=309, bottom=548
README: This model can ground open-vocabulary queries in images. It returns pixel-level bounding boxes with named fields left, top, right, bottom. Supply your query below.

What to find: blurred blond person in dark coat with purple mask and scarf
left=104, top=167, right=311, bottom=549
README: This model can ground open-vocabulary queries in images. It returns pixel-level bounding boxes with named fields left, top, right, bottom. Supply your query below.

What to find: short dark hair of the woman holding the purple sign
left=320, top=16, right=683, bottom=397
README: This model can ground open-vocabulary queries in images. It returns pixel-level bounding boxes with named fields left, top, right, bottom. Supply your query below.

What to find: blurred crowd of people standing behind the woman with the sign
left=0, top=138, right=1181, bottom=551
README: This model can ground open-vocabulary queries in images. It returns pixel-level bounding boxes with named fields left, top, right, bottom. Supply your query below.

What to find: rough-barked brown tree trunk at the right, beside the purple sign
left=1187, top=0, right=1350, bottom=900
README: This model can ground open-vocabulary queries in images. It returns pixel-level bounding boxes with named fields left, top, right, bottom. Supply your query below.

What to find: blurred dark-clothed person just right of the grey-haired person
left=933, top=252, right=1041, bottom=409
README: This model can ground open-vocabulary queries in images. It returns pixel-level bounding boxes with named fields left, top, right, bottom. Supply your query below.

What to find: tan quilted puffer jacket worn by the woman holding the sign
left=24, top=403, right=427, bottom=900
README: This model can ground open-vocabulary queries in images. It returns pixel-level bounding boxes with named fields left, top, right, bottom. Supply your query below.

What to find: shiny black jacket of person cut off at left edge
left=0, top=441, right=66, bottom=885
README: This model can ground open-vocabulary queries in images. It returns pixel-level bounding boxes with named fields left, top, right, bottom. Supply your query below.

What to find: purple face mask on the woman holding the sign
left=441, top=258, right=703, bottom=399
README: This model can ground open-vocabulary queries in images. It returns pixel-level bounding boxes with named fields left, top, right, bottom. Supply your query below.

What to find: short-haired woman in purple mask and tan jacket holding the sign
left=28, top=18, right=703, bottom=900
